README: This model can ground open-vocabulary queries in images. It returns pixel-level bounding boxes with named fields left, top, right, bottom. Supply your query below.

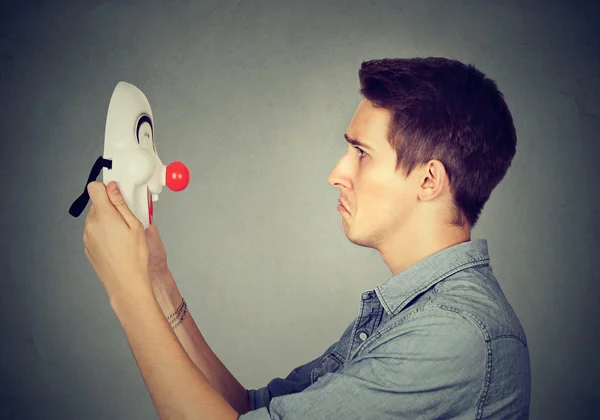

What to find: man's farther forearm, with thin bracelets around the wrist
left=154, top=272, right=250, bottom=414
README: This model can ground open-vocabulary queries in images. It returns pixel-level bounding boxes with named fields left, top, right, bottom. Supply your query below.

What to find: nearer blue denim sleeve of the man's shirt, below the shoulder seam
left=239, top=307, right=488, bottom=420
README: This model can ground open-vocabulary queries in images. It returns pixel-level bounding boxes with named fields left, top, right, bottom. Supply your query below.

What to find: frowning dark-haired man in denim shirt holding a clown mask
left=83, top=58, right=530, bottom=420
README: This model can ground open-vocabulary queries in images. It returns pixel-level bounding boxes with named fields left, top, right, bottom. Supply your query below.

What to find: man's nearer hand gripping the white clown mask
left=83, top=181, right=150, bottom=300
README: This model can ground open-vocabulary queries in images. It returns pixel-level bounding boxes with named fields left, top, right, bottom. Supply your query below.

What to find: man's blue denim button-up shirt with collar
left=240, top=239, right=531, bottom=420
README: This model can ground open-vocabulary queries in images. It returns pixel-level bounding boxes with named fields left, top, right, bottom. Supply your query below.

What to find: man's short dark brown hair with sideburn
left=358, top=57, right=517, bottom=229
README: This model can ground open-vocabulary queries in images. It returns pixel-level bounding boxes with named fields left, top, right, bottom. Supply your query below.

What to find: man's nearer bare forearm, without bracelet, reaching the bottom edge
left=110, top=288, right=239, bottom=420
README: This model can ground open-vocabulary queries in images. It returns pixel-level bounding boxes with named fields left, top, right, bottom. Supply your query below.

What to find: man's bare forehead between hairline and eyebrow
left=347, top=99, right=392, bottom=147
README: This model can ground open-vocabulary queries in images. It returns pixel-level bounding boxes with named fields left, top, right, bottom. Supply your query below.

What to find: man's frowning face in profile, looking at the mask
left=328, top=99, right=419, bottom=250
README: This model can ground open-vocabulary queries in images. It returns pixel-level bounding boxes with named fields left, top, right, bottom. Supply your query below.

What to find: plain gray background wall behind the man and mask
left=0, top=0, right=600, bottom=419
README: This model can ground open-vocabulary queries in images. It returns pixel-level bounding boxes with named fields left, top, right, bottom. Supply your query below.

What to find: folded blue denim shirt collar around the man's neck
left=375, top=239, right=489, bottom=315
